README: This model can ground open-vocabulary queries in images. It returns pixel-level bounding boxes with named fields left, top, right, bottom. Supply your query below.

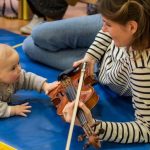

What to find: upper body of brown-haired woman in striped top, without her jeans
left=63, top=0, right=150, bottom=143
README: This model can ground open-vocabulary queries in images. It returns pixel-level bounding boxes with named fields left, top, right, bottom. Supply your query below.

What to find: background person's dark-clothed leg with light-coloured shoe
left=20, top=0, right=68, bottom=34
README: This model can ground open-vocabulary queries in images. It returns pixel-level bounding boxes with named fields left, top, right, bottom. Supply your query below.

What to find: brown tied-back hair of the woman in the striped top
left=97, top=0, right=150, bottom=51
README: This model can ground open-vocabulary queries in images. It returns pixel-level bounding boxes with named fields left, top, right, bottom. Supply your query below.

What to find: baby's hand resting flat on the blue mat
left=10, top=102, right=31, bottom=117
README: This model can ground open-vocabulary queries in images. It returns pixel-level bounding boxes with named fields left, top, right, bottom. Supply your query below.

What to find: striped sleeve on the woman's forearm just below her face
left=87, top=30, right=112, bottom=60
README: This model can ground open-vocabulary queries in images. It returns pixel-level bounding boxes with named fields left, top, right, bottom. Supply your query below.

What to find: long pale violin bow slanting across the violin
left=65, top=62, right=87, bottom=150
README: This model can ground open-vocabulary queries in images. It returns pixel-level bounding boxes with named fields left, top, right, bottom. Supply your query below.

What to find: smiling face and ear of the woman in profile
left=102, top=17, right=136, bottom=47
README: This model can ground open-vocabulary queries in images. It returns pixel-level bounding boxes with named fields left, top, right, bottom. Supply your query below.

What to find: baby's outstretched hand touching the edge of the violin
left=43, top=81, right=60, bottom=94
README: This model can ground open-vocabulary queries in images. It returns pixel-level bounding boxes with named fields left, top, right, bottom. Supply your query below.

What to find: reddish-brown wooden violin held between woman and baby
left=48, top=63, right=103, bottom=149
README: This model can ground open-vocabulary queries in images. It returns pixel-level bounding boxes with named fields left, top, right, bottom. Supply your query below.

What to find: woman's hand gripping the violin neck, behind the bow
left=63, top=102, right=94, bottom=126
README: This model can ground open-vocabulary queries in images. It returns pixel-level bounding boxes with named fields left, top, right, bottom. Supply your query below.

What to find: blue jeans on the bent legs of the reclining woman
left=23, top=14, right=102, bottom=70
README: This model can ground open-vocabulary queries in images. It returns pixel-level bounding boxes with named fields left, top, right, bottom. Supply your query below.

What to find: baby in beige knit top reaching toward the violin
left=0, top=44, right=59, bottom=118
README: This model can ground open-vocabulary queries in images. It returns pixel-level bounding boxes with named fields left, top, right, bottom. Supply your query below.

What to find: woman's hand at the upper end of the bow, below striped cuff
left=73, top=54, right=95, bottom=76
